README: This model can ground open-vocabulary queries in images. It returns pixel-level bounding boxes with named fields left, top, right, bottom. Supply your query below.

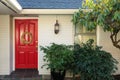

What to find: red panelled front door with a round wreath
left=15, top=19, right=38, bottom=69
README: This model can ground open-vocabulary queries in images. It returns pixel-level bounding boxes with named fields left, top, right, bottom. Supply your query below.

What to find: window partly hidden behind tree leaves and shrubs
left=75, top=25, right=96, bottom=44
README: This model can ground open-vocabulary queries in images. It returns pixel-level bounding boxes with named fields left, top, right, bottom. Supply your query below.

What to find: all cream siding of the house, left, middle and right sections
left=0, top=15, right=120, bottom=75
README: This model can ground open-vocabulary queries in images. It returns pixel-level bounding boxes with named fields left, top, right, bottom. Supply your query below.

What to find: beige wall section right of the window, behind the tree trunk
left=97, top=27, right=120, bottom=74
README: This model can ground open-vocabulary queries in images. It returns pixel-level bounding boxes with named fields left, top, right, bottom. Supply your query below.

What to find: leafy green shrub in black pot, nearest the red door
left=40, top=43, right=73, bottom=80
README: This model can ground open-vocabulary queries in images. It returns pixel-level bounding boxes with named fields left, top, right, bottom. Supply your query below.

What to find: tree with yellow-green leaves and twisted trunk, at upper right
left=73, top=0, right=120, bottom=49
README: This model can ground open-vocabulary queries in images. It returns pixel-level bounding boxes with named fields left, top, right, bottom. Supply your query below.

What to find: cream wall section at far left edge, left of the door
left=0, top=15, right=10, bottom=75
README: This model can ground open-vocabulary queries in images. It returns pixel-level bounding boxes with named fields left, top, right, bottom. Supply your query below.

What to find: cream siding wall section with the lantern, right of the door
left=38, top=15, right=74, bottom=74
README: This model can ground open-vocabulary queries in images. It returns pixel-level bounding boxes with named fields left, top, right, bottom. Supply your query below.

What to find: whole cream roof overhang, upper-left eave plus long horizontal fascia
left=0, top=0, right=78, bottom=15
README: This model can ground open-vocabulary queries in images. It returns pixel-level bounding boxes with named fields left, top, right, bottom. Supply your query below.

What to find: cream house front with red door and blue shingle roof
left=0, top=0, right=120, bottom=75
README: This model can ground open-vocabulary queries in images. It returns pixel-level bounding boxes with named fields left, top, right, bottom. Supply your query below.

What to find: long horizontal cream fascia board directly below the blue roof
left=20, top=9, right=78, bottom=14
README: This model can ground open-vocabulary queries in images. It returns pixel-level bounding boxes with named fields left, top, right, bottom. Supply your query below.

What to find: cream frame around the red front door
left=13, top=17, right=39, bottom=71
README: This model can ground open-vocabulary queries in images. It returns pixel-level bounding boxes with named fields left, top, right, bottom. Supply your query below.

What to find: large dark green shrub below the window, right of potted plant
left=74, top=39, right=117, bottom=80
